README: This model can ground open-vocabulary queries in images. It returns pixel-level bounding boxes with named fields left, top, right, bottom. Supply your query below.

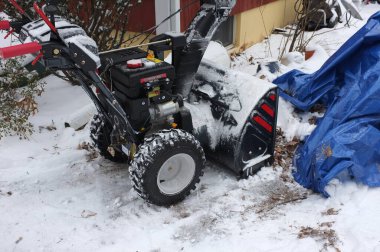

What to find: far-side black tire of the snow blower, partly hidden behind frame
left=90, top=114, right=128, bottom=163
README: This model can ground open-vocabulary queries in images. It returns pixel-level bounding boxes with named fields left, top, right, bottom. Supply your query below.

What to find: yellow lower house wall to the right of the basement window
left=234, top=0, right=295, bottom=49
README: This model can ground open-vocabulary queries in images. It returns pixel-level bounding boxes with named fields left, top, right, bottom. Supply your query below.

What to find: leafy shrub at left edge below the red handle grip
left=0, top=59, right=45, bottom=139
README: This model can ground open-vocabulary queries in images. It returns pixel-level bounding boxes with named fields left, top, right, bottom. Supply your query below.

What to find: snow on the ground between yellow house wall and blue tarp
left=232, top=3, right=378, bottom=80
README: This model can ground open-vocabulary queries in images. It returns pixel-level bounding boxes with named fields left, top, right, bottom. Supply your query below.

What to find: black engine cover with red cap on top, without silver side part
left=104, top=57, right=175, bottom=131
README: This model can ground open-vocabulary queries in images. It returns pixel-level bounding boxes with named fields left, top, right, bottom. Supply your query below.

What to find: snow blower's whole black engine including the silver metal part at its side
left=101, top=49, right=183, bottom=132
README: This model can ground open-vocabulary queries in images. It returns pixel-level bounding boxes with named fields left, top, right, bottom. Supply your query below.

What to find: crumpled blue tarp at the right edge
left=274, top=12, right=380, bottom=196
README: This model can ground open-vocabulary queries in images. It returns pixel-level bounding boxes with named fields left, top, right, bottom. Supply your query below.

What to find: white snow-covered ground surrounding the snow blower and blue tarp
left=0, top=2, right=380, bottom=252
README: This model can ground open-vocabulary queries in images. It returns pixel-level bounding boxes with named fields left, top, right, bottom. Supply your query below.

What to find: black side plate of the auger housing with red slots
left=205, top=89, right=278, bottom=178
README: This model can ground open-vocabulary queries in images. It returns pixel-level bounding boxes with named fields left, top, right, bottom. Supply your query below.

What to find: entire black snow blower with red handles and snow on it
left=0, top=0, right=278, bottom=206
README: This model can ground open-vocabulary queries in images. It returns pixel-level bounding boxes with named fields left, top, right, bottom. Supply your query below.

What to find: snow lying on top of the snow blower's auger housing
left=189, top=59, right=275, bottom=149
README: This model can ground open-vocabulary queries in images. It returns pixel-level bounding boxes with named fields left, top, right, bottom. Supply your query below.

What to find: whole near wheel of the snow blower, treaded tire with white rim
left=129, top=129, right=206, bottom=206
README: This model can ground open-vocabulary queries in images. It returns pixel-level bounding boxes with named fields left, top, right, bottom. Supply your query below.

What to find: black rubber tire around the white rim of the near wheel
left=129, top=129, right=206, bottom=206
